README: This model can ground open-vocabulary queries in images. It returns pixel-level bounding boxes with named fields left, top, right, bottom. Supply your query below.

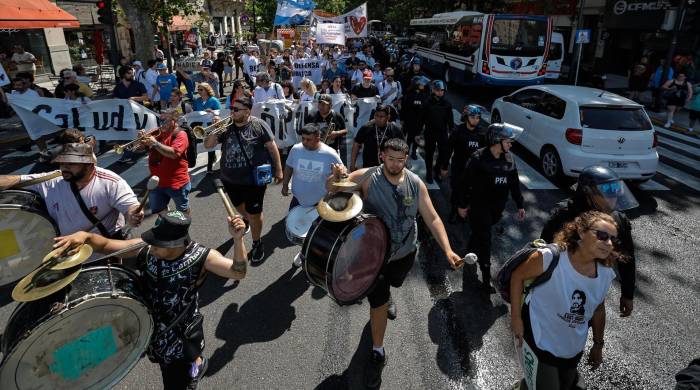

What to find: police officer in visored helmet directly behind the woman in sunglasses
left=540, top=166, right=639, bottom=317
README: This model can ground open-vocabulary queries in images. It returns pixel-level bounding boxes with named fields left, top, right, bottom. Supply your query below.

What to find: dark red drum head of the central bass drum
left=329, top=217, right=389, bottom=303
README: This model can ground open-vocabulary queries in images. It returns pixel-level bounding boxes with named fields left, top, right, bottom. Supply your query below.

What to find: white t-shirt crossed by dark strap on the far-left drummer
left=22, top=167, right=138, bottom=235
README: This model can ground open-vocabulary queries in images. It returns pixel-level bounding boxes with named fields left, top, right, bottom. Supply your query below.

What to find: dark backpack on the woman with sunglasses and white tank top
left=494, top=240, right=559, bottom=303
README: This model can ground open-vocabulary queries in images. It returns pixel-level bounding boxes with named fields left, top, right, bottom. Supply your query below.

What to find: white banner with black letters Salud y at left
left=7, top=95, right=158, bottom=141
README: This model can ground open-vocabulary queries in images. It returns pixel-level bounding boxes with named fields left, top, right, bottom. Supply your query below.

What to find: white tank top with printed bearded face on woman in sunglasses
left=525, top=249, right=615, bottom=359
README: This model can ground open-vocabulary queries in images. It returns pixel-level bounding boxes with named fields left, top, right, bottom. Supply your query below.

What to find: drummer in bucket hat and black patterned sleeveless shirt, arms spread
left=54, top=211, right=247, bottom=390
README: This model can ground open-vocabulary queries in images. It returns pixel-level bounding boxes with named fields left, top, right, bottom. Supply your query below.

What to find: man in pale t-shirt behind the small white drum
left=282, top=123, right=343, bottom=267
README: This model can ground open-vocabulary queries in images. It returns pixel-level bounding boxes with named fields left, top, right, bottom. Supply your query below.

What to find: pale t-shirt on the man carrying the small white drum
left=286, top=142, right=342, bottom=207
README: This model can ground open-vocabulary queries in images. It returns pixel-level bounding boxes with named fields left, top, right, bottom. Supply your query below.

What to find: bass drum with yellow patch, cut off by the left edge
left=0, top=190, right=59, bottom=286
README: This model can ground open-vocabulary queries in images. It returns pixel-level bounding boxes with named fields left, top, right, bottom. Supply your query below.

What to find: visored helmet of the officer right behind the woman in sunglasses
left=576, top=165, right=639, bottom=212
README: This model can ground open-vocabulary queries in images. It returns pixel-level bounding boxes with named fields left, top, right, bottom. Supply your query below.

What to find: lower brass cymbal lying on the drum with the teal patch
left=12, top=265, right=81, bottom=302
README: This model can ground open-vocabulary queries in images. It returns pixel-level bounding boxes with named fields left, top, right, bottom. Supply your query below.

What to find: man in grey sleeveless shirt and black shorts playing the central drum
left=326, top=138, right=463, bottom=388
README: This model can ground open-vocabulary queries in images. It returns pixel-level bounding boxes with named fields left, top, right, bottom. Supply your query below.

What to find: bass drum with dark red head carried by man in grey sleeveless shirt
left=301, top=214, right=389, bottom=305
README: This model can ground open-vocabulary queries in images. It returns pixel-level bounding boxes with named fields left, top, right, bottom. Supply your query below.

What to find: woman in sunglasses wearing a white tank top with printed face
left=510, top=211, right=626, bottom=390
